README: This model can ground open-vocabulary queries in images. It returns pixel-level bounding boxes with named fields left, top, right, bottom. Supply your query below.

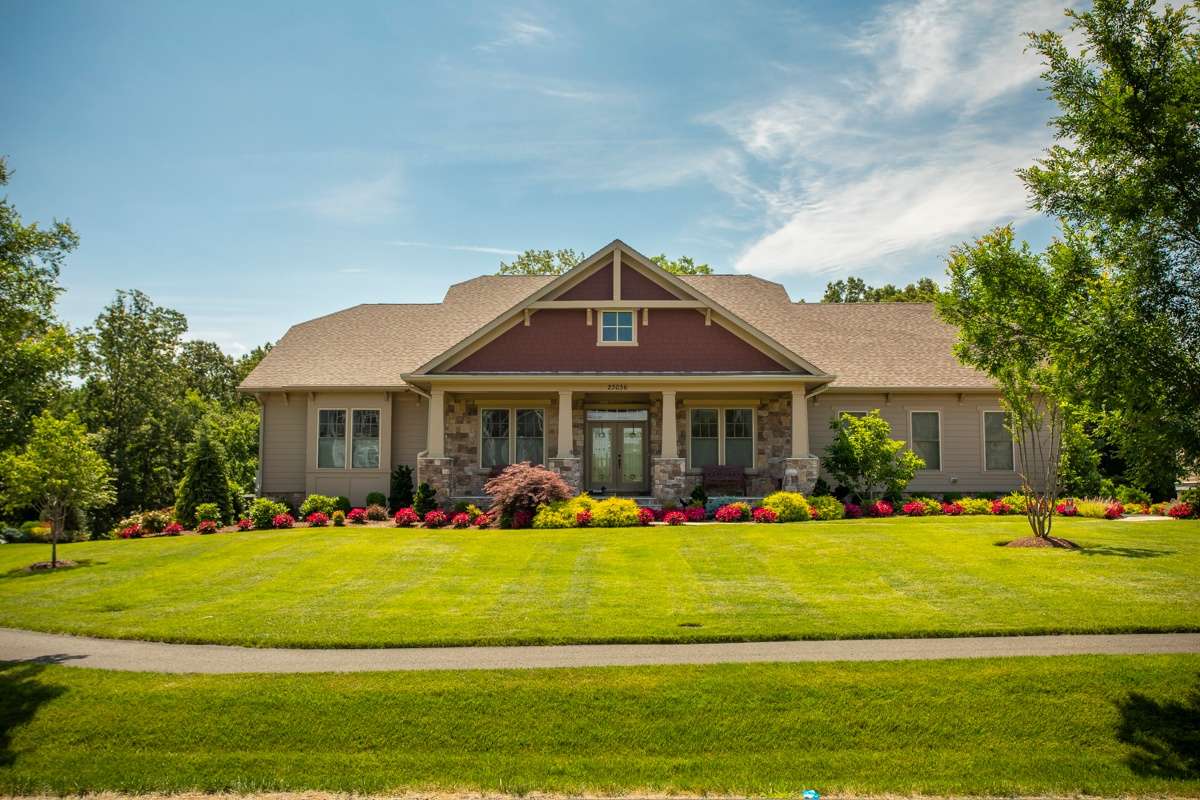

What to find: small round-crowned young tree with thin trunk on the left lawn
left=0, top=411, right=113, bottom=567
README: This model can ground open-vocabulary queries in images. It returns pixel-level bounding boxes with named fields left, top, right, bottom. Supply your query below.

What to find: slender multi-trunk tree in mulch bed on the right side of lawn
left=937, top=227, right=1092, bottom=540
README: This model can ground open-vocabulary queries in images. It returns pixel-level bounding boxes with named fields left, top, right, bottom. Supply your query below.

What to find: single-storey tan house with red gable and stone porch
left=241, top=241, right=1019, bottom=504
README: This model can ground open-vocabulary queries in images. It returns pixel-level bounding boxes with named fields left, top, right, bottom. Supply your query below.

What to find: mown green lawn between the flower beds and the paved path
left=0, top=517, right=1200, bottom=646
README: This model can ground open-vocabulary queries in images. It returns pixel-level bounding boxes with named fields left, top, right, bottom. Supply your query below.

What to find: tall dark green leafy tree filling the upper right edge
left=1019, top=0, right=1200, bottom=486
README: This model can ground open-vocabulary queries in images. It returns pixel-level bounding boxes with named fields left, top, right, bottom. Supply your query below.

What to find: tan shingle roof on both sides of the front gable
left=242, top=275, right=992, bottom=391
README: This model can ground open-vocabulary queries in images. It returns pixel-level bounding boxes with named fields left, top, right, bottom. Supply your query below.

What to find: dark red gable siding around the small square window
left=450, top=308, right=787, bottom=373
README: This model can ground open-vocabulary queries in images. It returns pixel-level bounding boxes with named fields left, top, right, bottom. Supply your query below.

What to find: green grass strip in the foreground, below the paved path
left=0, top=656, right=1200, bottom=796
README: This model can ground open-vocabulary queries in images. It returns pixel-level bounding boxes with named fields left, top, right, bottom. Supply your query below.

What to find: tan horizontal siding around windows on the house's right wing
left=809, top=391, right=1020, bottom=493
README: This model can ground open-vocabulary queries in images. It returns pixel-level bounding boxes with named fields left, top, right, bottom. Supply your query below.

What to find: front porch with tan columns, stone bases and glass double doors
left=416, top=379, right=818, bottom=504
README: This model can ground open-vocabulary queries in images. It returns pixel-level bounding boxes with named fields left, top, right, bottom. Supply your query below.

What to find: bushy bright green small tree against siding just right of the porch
left=824, top=410, right=925, bottom=503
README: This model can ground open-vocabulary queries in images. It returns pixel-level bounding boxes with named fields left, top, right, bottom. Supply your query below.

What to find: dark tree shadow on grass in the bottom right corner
left=1117, top=678, right=1200, bottom=780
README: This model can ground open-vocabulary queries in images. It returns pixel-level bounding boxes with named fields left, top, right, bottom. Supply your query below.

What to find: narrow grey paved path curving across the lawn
left=0, top=628, right=1200, bottom=673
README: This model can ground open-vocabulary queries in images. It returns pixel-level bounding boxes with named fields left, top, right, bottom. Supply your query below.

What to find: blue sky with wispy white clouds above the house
left=0, top=0, right=1063, bottom=354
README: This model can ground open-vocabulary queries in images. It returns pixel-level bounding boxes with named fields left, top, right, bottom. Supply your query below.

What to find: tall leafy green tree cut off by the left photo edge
left=0, top=157, right=79, bottom=451
